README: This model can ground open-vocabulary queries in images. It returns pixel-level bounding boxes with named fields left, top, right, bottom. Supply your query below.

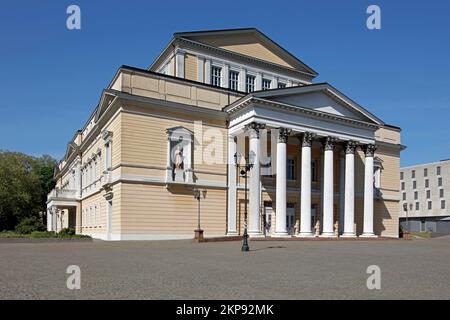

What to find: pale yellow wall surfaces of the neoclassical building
left=49, top=28, right=402, bottom=240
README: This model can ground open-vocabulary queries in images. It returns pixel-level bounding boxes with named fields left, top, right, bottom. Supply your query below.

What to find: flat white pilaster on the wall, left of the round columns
left=227, top=135, right=237, bottom=235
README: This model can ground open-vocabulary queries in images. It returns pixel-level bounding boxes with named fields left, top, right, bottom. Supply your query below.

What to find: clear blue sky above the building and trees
left=0, top=0, right=450, bottom=165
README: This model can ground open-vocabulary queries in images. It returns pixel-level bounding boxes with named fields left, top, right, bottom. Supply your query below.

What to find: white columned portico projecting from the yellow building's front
left=227, top=85, right=378, bottom=237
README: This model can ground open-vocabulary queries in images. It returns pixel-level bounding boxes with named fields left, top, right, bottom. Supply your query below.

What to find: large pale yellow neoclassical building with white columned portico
left=47, top=29, right=404, bottom=240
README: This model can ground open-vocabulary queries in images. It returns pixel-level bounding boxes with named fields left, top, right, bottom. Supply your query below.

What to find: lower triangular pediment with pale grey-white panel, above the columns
left=253, top=83, right=383, bottom=125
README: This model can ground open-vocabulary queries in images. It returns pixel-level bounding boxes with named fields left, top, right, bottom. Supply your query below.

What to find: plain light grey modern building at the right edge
left=400, top=159, right=450, bottom=233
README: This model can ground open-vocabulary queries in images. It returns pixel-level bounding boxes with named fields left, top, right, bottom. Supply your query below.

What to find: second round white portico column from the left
left=275, top=128, right=290, bottom=237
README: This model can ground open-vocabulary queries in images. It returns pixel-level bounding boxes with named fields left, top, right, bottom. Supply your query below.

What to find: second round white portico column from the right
left=342, top=141, right=356, bottom=237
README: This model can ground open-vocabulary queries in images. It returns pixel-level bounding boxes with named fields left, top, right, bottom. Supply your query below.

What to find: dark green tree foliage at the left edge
left=0, top=150, right=56, bottom=230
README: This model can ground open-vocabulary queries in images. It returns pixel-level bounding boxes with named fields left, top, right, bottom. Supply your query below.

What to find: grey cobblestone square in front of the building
left=0, top=236, right=450, bottom=299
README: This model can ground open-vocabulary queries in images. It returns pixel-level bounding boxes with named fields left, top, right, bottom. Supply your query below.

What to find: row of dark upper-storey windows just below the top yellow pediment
left=211, top=66, right=286, bottom=93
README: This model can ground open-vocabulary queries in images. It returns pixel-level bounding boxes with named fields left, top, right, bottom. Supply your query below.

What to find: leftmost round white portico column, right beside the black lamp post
left=247, top=123, right=263, bottom=236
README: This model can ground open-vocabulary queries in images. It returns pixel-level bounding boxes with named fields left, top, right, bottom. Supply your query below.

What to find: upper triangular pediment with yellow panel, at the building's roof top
left=176, top=28, right=317, bottom=75
